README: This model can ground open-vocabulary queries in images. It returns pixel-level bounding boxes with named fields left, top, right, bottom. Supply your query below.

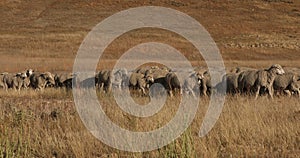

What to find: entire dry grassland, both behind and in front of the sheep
left=0, top=0, right=300, bottom=157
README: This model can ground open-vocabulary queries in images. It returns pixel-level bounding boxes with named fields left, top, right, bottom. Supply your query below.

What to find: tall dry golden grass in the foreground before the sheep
left=0, top=89, right=300, bottom=157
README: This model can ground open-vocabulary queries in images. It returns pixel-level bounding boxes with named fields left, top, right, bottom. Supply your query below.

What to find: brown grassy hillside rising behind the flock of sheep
left=0, top=0, right=300, bottom=71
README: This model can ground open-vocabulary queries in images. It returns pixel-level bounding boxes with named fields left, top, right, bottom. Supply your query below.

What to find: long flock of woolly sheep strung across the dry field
left=0, top=64, right=300, bottom=98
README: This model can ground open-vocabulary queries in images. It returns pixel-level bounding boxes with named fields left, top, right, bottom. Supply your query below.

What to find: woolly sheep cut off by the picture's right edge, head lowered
left=273, top=72, right=300, bottom=97
